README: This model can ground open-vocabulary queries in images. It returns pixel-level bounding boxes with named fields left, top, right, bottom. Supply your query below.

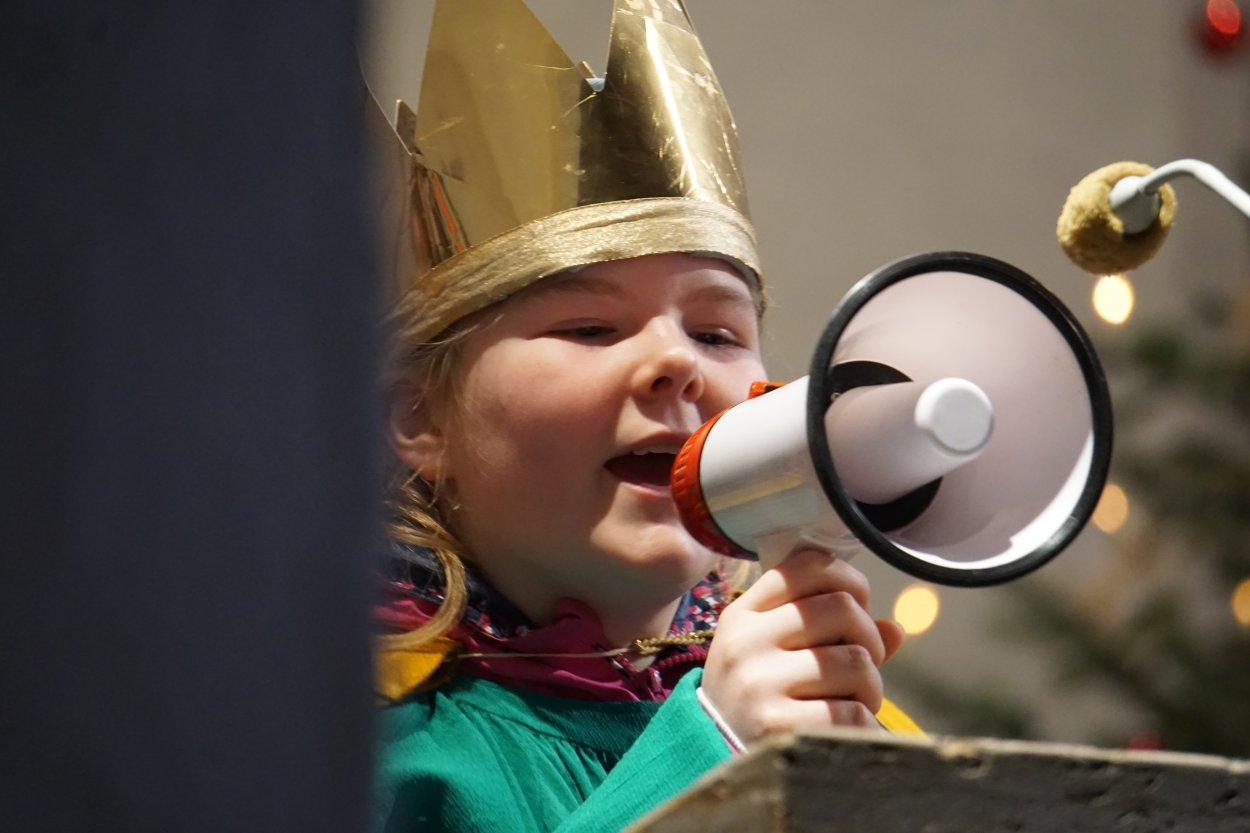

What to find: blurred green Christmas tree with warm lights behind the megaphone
left=891, top=281, right=1250, bottom=757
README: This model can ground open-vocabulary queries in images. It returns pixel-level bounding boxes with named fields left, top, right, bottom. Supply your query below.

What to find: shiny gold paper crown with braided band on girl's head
left=370, top=0, right=759, bottom=340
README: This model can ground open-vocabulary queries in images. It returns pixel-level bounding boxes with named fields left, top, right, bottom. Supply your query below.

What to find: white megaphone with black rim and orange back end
left=671, top=251, right=1111, bottom=587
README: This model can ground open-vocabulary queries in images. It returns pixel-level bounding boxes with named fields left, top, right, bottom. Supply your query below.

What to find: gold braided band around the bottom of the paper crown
left=394, top=198, right=764, bottom=343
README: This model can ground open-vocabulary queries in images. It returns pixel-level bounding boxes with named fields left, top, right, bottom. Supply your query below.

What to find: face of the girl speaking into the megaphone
left=419, top=254, right=765, bottom=618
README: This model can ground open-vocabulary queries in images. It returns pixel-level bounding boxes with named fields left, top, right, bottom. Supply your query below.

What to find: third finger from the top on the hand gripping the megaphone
left=773, top=637, right=884, bottom=714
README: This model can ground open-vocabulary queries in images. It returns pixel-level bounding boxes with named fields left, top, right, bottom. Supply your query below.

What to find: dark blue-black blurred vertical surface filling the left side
left=0, top=0, right=378, bottom=833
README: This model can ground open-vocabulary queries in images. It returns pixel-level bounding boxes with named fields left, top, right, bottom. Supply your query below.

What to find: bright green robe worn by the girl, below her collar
left=375, top=668, right=731, bottom=833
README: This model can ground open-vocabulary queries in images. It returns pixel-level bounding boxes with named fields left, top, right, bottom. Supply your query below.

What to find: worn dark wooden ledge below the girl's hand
left=630, top=729, right=1250, bottom=833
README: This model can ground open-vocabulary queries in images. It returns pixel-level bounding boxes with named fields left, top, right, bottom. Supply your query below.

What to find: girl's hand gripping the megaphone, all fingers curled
left=703, top=549, right=903, bottom=743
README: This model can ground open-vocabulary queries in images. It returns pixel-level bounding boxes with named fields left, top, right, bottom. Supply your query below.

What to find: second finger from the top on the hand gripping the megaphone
left=758, top=590, right=885, bottom=664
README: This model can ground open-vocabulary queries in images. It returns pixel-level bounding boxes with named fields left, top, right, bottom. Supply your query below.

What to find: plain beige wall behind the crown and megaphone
left=363, top=0, right=1250, bottom=739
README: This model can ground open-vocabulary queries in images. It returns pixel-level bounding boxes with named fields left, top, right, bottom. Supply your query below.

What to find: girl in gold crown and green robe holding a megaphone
left=376, top=0, right=903, bottom=830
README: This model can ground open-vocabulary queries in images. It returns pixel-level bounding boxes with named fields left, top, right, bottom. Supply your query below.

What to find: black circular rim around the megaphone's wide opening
left=808, top=251, right=1111, bottom=587
